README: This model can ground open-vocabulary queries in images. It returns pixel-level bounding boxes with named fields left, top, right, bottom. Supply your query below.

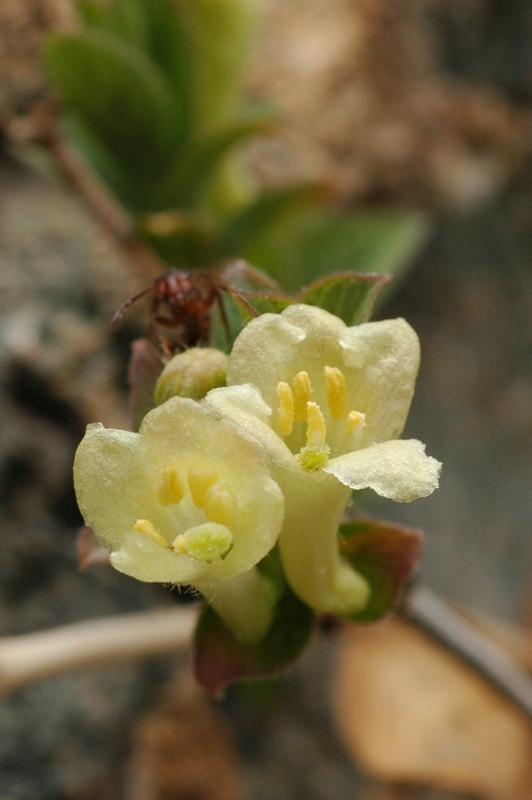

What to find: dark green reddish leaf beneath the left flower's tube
left=194, top=586, right=314, bottom=696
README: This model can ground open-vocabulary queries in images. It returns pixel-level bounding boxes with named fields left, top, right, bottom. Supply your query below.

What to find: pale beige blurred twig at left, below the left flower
left=0, top=607, right=198, bottom=695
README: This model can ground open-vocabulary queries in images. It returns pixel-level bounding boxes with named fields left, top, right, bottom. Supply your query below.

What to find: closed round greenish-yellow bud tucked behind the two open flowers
left=155, top=347, right=228, bottom=406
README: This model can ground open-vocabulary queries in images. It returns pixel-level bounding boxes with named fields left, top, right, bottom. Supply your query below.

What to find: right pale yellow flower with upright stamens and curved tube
left=207, top=305, right=441, bottom=614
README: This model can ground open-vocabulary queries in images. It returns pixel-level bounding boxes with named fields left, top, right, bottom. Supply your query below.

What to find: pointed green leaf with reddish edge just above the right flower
left=297, top=272, right=390, bottom=325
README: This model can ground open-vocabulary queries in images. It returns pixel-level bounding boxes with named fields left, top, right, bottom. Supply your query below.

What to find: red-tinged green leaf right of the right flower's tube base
left=338, top=520, right=423, bottom=623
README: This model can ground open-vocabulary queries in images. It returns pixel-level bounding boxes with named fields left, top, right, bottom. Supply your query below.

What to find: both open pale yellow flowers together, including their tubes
left=75, top=305, right=440, bottom=641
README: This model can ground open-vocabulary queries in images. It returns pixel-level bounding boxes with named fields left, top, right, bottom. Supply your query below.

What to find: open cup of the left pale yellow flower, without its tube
left=74, top=397, right=284, bottom=594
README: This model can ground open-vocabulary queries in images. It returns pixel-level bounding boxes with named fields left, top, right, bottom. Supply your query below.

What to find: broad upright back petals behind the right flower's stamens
left=227, top=305, right=419, bottom=455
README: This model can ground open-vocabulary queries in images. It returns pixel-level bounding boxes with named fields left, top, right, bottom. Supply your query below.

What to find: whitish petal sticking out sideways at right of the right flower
left=324, top=439, right=441, bottom=503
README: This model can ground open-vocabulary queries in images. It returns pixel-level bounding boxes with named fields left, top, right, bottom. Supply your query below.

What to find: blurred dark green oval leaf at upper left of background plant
left=45, top=30, right=183, bottom=184
